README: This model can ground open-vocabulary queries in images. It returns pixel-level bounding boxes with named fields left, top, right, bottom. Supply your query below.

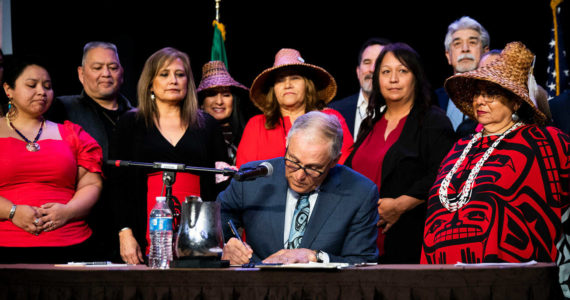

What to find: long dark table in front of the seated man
left=0, top=263, right=561, bottom=300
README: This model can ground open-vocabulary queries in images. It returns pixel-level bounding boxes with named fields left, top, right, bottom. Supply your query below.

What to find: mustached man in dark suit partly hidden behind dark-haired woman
left=328, top=38, right=390, bottom=141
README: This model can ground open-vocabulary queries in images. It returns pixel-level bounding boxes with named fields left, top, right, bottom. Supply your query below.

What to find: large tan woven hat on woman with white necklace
left=444, top=42, right=546, bottom=121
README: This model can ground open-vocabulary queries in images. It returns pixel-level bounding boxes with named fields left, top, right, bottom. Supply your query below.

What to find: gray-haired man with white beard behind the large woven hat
left=435, top=16, right=490, bottom=137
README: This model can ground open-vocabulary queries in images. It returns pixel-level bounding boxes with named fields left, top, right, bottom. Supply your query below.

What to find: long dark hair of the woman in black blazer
left=356, top=43, right=432, bottom=144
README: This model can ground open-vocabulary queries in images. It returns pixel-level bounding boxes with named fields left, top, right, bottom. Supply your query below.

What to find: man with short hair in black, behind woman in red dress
left=46, top=41, right=132, bottom=260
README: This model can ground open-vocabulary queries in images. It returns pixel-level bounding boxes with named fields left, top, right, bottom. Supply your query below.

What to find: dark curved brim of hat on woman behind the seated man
left=249, top=63, right=337, bottom=111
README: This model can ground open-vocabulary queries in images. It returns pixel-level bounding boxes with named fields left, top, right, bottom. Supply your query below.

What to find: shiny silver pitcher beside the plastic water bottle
left=174, top=196, right=223, bottom=259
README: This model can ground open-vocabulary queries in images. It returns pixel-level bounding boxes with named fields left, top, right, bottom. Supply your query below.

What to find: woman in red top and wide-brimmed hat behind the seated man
left=236, top=49, right=353, bottom=167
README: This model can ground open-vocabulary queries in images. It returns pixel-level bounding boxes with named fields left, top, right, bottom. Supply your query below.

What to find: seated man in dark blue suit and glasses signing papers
left=218, top=111, right=379, bottom=264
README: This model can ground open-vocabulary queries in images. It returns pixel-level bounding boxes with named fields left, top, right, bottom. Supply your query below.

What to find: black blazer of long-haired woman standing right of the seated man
left=345, top=106, right=456, bottom=263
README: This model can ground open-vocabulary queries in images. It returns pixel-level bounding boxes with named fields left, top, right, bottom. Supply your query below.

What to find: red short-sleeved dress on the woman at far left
left=0, top=121, right=103, bottom=247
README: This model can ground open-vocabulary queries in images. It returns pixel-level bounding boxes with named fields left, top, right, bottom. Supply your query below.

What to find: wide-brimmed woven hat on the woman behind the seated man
left=249, top=48, right=337, bottom=111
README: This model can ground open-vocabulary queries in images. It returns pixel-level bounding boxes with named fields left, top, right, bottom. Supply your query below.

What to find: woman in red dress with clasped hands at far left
left=0, top=59, right=102, bottom=263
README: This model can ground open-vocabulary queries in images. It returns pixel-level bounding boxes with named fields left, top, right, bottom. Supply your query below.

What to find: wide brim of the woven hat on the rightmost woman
left=444, top=71, right=546, bottom=121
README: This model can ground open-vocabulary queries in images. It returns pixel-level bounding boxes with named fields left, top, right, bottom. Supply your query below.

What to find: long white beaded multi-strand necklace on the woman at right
left=439, top=122, right=524, bottom=212
